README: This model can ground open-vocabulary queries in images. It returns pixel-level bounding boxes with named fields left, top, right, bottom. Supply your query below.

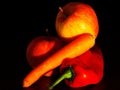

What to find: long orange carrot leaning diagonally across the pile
left=23, top=34, right=95, bottom=87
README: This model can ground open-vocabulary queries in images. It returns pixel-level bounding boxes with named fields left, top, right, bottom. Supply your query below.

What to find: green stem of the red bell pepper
left=48, top=67, right=73, bottom=90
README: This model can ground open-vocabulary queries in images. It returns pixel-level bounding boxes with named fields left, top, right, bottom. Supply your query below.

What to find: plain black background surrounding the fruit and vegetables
left=0, top=0, right=120, bottom=90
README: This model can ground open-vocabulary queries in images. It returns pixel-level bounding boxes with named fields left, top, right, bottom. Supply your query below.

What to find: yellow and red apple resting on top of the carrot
left=55, top=2, right=99, bottom=39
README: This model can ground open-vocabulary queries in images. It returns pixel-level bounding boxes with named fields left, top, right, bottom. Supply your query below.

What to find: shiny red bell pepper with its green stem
left=49, top=47, right=104, bottom=89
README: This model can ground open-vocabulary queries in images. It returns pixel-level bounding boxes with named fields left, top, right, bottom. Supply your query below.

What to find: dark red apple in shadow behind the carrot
left=26, top=36, right=64, bottom=76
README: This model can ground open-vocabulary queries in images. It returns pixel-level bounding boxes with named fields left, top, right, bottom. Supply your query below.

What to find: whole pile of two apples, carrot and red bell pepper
left=23, top=2, right=104, bottom=89
